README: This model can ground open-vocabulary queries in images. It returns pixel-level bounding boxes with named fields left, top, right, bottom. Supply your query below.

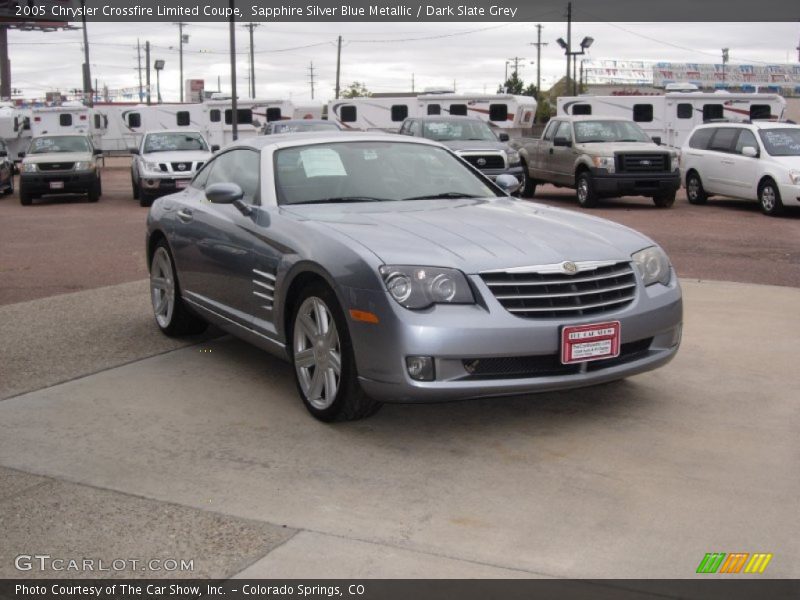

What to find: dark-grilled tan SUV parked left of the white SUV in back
left=19, top=134, right=103, bottom=206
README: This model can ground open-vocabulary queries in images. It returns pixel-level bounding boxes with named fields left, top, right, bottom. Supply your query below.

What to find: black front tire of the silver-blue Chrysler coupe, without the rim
left=287, top=283, right=381, bottom=423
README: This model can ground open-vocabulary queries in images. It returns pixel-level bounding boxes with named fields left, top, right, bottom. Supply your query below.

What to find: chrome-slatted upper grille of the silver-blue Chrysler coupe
left=481, top=262, right=636, bottom=319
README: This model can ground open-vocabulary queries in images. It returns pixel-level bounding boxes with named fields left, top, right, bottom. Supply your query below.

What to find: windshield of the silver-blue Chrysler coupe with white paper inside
left=275, top=141, right=501, bottom=204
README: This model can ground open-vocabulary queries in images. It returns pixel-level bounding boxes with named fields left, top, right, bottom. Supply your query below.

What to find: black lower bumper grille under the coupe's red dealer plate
left=461, top=338, right=653, bottom=379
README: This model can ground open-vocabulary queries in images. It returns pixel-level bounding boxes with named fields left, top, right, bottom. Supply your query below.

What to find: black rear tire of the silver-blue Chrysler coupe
left=149, top=240, right=208, bottom=337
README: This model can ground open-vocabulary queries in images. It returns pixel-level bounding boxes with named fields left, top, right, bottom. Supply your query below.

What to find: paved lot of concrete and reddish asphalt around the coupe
left=0, top=160, right=800, bottom=578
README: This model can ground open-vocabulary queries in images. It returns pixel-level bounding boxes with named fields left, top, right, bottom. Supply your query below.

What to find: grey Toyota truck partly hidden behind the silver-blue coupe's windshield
left=398, top=116, right=524, bottom=181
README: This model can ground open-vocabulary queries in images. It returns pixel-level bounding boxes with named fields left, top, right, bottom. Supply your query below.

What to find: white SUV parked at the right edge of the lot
left=681, top=121, right=800, bottom=216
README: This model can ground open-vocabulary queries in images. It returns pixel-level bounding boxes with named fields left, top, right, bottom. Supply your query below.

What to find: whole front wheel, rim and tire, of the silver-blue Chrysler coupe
left=290, top=283, right=381, bottom=422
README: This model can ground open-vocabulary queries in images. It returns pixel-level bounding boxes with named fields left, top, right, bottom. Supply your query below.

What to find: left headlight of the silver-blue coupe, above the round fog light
left=380, top=265, right=475, bottom=309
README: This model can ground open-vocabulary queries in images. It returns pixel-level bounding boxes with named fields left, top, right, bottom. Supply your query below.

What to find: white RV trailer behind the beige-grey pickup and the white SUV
left=557, top=92, right=786, bottom=148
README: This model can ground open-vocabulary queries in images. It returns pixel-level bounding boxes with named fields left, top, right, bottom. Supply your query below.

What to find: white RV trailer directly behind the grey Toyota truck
left=328, top=93, right=536, bottom=137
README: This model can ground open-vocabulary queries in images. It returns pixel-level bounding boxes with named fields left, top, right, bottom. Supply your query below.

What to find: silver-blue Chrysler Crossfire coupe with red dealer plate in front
left=147, top=132, right=682, bottom=421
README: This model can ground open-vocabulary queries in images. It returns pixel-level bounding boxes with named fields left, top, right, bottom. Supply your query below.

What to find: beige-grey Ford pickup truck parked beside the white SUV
left=511, top=116, right=681, bottom=208
